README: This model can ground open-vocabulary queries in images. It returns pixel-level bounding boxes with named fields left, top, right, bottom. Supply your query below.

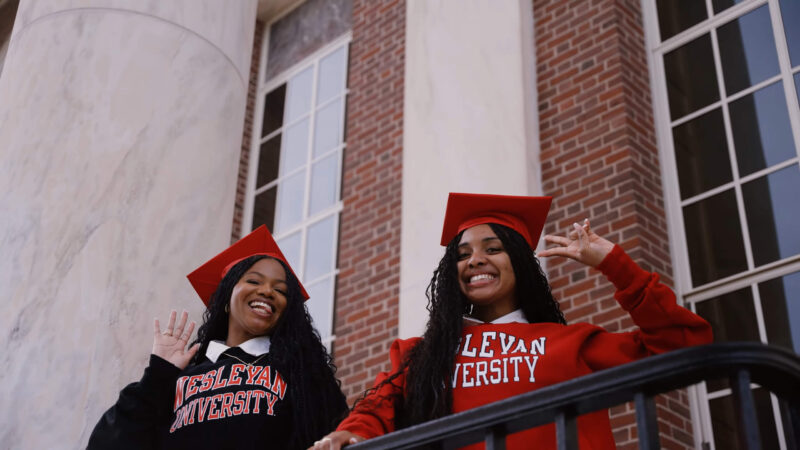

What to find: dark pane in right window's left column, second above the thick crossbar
left=672, top=108, right=733, bottom=199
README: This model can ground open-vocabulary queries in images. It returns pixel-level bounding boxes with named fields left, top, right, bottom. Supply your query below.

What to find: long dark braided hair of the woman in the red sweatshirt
left=356, top=223, right=566, bottom=429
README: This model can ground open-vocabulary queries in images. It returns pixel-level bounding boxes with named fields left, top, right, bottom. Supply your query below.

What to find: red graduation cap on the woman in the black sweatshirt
left=186, top=225, right=308, bottom=306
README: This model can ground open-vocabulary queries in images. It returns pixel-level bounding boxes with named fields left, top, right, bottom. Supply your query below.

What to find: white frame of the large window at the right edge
left=642, top=0, right=800, bottom=450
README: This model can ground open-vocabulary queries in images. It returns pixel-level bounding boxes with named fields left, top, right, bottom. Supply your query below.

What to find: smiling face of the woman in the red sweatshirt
left=458, top=224, right=517, bottom=322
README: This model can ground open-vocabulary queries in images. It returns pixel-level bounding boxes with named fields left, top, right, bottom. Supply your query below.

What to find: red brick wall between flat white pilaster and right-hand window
left=533, top=0, right=693, bottom=449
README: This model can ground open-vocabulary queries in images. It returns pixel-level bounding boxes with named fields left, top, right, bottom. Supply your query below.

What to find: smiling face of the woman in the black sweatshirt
left=226, top=258, right=288, bottom=347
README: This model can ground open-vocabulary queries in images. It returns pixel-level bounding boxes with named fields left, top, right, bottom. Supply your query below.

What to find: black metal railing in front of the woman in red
left=348, top=342, right=800, bottom=450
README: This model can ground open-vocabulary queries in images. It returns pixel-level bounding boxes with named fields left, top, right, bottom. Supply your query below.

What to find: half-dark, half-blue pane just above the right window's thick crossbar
left=742, top=164, right=800, bottom=266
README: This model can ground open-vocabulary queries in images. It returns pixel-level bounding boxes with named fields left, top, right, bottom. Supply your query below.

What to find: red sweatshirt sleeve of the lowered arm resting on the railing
left=336, top=338, right=419, bottom=439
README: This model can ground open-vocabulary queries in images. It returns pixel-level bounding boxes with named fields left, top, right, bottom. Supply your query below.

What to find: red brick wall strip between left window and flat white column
left=334, top=0, right=406, bottom=401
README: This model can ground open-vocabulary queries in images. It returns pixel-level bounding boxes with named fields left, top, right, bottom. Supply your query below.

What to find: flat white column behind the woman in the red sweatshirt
left=399, top=0, right=541, bottom=337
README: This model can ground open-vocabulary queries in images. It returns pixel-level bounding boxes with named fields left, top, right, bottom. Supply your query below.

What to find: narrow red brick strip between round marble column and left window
left=231, top=21, right=264, bottom=244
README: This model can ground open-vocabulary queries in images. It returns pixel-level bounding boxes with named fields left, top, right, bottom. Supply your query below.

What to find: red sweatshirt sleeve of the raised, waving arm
left=581, top=245, right=713, bottom=370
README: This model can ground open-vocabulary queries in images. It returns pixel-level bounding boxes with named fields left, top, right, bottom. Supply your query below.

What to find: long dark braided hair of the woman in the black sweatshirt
left=192, top=255, right=347, bottom=449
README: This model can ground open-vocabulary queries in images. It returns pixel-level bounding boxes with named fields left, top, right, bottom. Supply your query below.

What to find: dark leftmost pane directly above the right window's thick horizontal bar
left=683, top=190, right=747, bottom=286
